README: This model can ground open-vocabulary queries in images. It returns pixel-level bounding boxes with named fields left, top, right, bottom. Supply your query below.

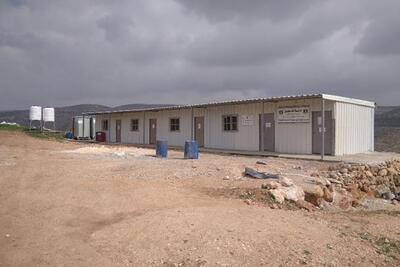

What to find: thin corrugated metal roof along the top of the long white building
left=83, top=94, right=375, bottom=115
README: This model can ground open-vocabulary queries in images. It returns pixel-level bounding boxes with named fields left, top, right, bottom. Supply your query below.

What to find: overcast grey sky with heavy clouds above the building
left=0, top=0, right=400, bottom=110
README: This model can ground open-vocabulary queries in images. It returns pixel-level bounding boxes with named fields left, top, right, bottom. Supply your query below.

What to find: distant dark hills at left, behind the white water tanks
left=0, top=104, right=175, bottom=131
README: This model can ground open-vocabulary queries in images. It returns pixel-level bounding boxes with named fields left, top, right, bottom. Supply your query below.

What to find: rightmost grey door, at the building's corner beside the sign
left=312, top=111, right=334, bottom=155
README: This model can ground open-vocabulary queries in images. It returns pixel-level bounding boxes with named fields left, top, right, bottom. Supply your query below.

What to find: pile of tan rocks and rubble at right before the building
left=261, top=160, right=400, bottom=214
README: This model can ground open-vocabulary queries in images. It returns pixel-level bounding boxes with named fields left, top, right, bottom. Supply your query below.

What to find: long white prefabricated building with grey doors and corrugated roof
left=87, top=94, right=375, bottom=155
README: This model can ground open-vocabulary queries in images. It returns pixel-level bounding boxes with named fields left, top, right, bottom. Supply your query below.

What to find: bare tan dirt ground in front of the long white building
left=0, top=132, right=400, bottom=266
